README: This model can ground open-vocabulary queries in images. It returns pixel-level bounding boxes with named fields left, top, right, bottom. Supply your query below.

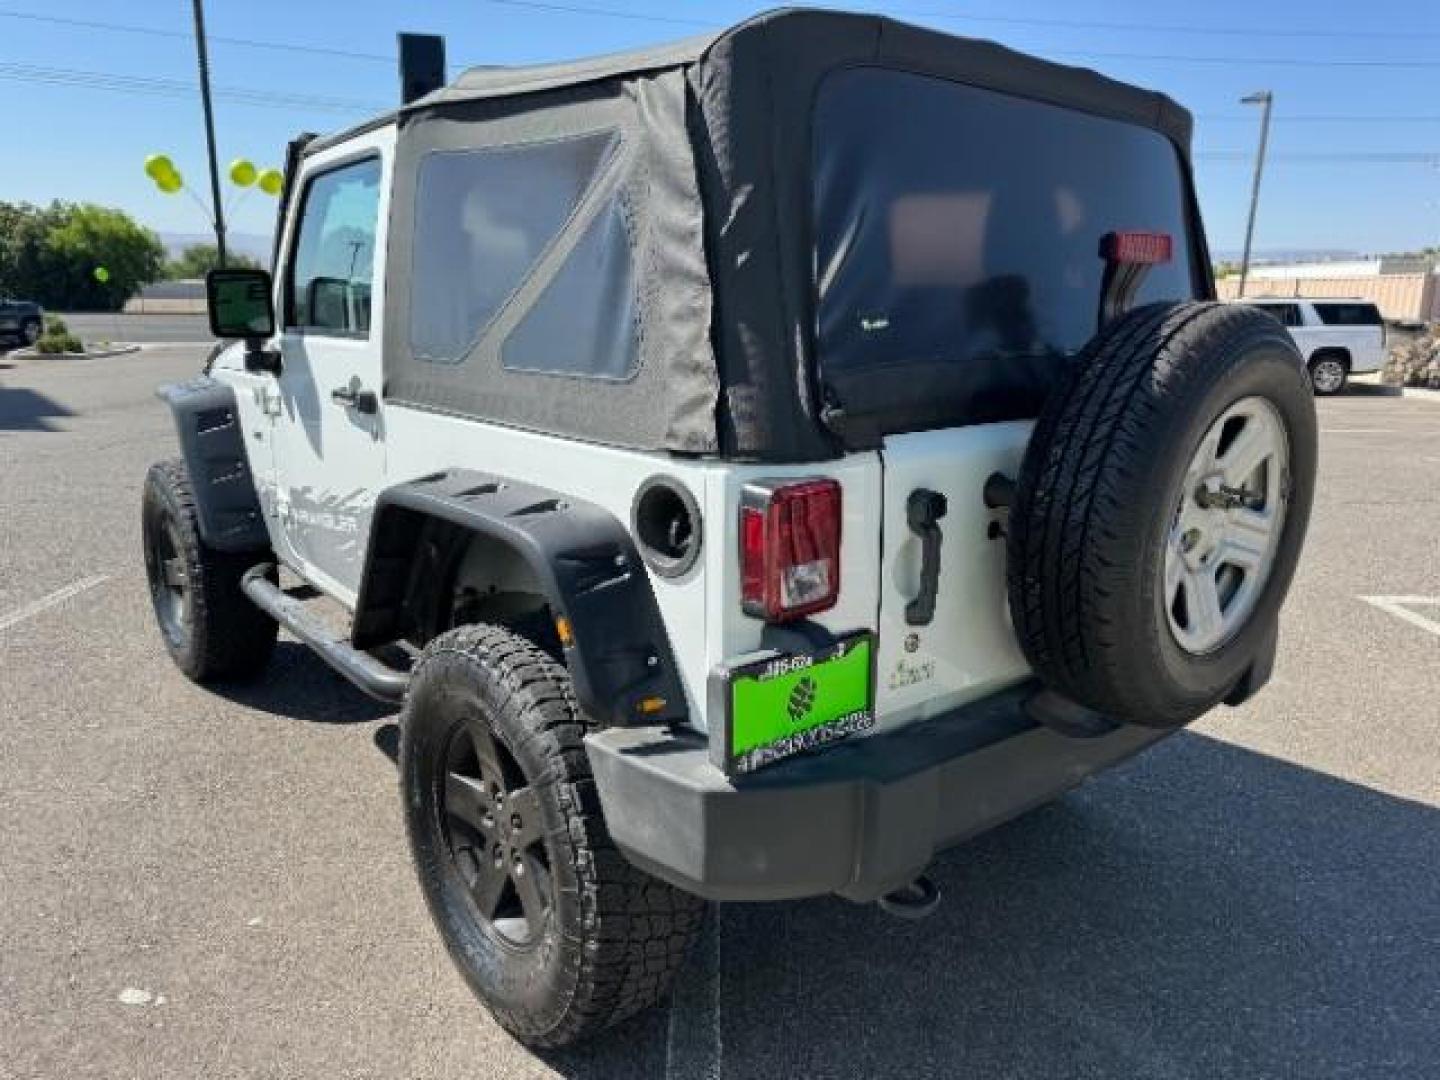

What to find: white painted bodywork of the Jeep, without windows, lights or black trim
left=215, top=120, right=1031, bottom=732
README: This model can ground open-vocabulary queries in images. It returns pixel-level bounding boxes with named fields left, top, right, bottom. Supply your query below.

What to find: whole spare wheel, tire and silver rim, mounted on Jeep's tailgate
left=1008, top=302, right=1316, bottom=727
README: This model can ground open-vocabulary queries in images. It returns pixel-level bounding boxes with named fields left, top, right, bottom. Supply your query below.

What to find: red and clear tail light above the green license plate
left=740, top=480, right=840, bottom=622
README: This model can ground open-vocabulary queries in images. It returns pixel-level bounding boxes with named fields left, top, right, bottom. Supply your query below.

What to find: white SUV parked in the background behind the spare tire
left=1244, top=297, right=1385, bottom=396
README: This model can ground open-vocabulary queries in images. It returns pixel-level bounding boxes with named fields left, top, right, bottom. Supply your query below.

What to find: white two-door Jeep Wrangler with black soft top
left=144, top=10, right=1316, bottom=1045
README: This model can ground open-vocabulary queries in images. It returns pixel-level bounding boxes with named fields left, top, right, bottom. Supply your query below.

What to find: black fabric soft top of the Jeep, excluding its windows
left=368, top=9, right=1202, bottom=461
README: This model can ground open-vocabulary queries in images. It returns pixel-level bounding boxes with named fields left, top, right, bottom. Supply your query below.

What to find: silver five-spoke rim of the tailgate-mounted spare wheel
left=1164, top=397, right=1290, bottom=655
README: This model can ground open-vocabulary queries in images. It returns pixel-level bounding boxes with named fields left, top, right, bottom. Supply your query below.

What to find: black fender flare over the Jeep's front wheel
left=156, top=376, right=269, bottom=552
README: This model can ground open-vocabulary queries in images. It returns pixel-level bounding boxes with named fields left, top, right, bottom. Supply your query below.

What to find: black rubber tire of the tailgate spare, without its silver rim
left=1008, top=302, right=1316, bottom=727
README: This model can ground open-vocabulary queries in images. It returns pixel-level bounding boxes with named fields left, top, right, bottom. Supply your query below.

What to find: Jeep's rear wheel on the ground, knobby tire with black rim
left=400, top=625, right=704, bottom=1047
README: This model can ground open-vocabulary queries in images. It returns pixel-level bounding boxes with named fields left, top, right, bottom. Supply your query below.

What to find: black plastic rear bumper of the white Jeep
left=585, top=683, right=1169, bottom=900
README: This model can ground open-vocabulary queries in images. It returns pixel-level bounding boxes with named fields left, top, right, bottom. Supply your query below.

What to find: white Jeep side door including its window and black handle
left=271, top=127, right=395, bottom=603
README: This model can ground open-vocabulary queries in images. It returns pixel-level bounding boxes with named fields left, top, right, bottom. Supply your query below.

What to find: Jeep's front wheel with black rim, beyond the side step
left=141, top=458, right=279, bottom=683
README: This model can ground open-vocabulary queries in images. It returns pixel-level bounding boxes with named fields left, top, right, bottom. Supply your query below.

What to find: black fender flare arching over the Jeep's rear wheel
left=351, top=469, right=688, bottom=724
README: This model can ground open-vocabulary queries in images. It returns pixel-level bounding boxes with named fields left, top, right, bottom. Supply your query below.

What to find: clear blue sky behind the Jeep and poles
left=0, top=0, right=1440, bottom=252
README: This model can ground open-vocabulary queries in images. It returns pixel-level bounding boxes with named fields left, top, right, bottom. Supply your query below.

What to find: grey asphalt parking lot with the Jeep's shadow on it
left=0, top=346, right=1440, bottom=1080
